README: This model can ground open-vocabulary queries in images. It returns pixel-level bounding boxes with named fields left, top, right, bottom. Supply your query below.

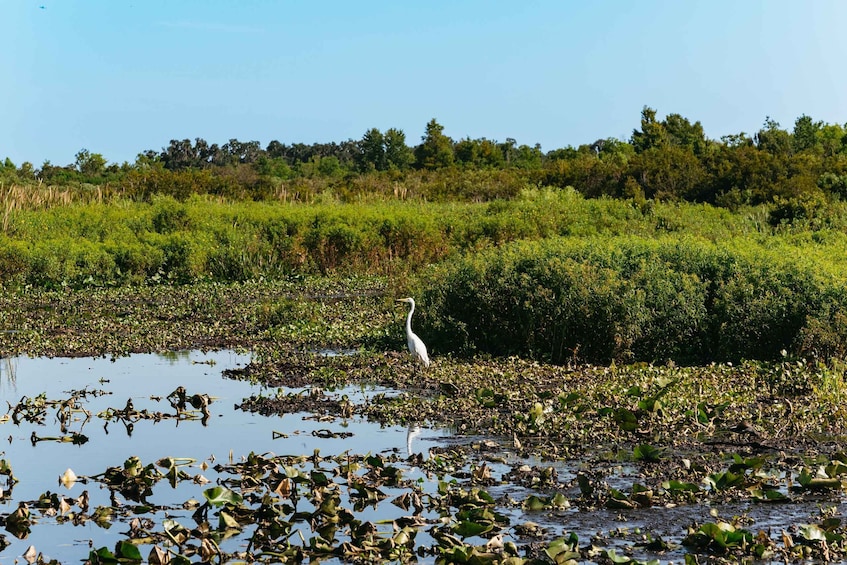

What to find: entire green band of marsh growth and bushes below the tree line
left=0, top=190, right=847, bottom=364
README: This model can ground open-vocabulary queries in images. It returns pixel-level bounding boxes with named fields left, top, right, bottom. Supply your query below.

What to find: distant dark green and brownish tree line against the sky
left=0, top=107, right=847, bottom=216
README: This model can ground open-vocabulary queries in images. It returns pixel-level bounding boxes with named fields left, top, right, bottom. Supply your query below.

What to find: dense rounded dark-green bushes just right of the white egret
left=419, top=237, right=847, bottom=363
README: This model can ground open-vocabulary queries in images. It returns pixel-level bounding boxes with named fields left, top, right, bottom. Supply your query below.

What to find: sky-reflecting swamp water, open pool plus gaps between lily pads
left=0, top=351, right=844, bottom=563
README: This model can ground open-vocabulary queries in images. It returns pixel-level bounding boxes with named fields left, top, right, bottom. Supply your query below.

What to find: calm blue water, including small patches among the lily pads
left=0, top=351, right=845, bottom=564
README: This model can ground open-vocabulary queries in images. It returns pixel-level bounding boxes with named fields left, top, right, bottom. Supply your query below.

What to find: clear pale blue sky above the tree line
left=0, top=0, right=847, bottom=167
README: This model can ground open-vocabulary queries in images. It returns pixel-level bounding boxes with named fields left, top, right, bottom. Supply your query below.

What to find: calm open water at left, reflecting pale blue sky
left=0, top=351, right=448, bottom=563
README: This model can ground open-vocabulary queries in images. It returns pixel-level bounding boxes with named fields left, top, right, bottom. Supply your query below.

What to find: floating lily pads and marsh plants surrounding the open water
left=0, top=278, right=847, bottom=563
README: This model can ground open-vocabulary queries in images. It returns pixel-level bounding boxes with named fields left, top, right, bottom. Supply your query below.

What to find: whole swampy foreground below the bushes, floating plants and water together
left=0, top=283, right=847, bottom=564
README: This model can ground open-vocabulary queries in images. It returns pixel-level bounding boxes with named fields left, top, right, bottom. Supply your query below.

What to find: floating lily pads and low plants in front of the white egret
left=0, top=353, right=847, bottom=563
